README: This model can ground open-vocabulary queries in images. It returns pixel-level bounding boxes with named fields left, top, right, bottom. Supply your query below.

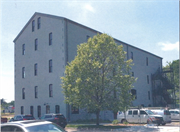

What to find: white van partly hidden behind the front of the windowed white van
left=151, top=109, right=171, bottom=125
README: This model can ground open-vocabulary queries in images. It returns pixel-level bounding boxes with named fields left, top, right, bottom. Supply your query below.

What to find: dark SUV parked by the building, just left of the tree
left=40, top=113, right=67, bottom=128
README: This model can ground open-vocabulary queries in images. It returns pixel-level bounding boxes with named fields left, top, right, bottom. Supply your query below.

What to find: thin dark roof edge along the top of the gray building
left=13, top=12, right=162, bottom=59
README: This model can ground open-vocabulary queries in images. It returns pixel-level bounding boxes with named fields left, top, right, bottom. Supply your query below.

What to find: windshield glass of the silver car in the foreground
left=26, top=123, right=65, bottom=132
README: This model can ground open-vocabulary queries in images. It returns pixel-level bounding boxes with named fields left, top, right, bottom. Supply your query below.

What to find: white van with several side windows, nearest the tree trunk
left=117, top=109, right=163, bottom=125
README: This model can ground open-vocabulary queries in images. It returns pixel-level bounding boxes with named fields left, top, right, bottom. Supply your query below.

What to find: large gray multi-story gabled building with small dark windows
left=14, top=13, right=172, bottom=121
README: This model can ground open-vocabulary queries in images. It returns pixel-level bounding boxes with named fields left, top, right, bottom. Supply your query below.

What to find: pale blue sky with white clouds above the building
left=0, top=0, right=179, bottom=102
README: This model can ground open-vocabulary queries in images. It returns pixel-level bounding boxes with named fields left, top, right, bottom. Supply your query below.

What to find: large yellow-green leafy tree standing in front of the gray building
left=61, top=34, right=135, bottom=125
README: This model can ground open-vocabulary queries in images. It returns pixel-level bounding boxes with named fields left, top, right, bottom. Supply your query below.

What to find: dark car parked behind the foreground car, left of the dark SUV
left=9, top=115, right=35, bottom=122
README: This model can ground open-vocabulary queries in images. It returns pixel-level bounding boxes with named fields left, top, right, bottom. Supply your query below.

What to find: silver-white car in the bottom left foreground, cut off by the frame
left=1, top=120, right=66, bottom=132
